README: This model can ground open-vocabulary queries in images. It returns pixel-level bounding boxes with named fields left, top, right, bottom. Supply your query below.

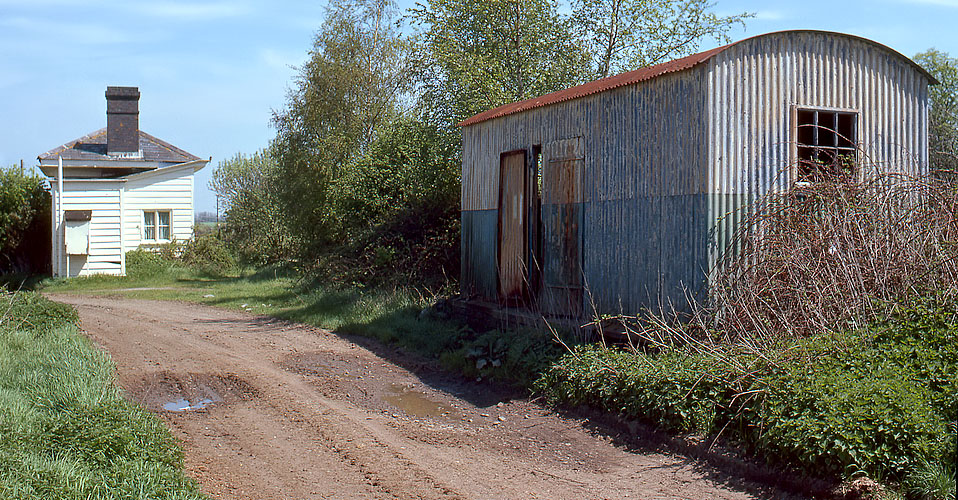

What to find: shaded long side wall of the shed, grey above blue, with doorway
left=461, top=68, right=708, bottom=312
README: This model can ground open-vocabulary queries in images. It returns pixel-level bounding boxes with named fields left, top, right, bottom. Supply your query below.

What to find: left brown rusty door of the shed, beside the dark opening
left=498, top=150, right=529, bottom=302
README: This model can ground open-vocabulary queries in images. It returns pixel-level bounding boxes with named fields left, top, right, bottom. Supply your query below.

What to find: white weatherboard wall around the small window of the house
left=123, top=166, right=195, bottom=251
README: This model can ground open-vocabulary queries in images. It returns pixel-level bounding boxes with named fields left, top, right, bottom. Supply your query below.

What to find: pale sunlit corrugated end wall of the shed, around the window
left=706, top=32, right=928, bottom=270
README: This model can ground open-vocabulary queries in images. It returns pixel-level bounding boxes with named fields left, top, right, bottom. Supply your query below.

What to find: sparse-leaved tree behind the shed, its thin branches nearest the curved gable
left=572, top=0, right=752, bottom=77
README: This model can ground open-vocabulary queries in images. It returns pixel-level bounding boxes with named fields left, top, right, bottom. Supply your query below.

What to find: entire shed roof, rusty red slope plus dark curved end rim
left=459, top=30, right=938, bottom=127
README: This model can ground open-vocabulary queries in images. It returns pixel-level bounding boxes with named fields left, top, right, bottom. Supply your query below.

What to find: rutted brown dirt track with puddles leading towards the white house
left=51, top=295, right=796, bottom=500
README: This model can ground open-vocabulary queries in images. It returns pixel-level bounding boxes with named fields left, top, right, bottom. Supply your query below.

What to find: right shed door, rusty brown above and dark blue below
left=540, top=137, right=584, bottom=318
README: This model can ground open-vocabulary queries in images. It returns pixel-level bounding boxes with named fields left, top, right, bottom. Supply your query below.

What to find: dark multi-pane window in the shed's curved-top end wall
left=796, top=108, right=858, bottom=182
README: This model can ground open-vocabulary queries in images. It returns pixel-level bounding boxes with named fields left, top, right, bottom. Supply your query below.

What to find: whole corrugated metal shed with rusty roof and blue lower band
left=462, top=31, right=934, bottom=316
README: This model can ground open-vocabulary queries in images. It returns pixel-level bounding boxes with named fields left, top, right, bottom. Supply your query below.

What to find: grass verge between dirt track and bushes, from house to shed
left=40, top=252, right=572, bottom=388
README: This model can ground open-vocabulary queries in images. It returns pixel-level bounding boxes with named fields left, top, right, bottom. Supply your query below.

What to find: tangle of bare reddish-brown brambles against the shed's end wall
left=698, top=174, right=958, bottom=337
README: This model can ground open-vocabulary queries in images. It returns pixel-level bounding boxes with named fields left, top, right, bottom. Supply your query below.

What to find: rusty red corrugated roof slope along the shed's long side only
left=459, top=45, right=728, bottom=127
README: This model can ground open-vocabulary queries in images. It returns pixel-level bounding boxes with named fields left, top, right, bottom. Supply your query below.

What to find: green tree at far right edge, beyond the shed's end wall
left=915, top=49, right=958, bottom=172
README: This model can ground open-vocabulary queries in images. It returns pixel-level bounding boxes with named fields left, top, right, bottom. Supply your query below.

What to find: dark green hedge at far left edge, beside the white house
left=0, top=166, right=50, bottom=273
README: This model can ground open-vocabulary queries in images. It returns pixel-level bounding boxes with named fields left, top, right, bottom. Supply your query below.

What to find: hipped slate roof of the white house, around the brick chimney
left=37, top=127, right=200, bottom=163
